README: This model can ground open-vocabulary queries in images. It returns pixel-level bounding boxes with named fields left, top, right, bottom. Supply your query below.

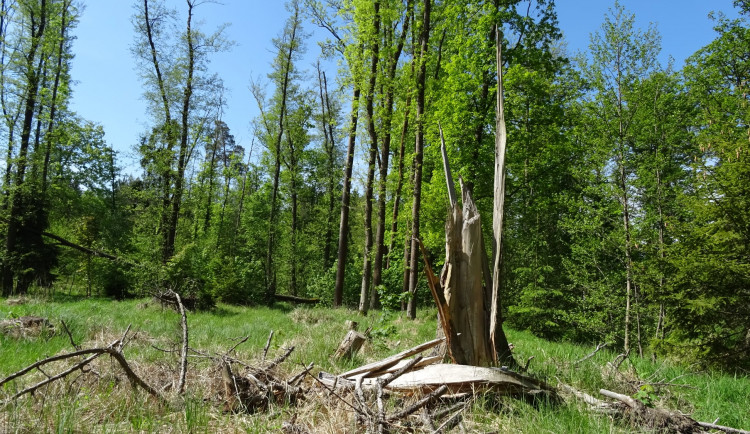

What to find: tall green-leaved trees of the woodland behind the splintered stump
left=0, top=0, right=750, bottom=368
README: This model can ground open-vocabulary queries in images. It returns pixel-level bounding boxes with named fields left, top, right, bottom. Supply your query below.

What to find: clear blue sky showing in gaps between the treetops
left=67, top=0, right=736, bottom=173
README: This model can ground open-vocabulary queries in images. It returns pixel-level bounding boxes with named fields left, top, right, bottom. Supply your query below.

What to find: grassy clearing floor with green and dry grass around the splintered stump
left=0, top=296, right=750, bottom=433
